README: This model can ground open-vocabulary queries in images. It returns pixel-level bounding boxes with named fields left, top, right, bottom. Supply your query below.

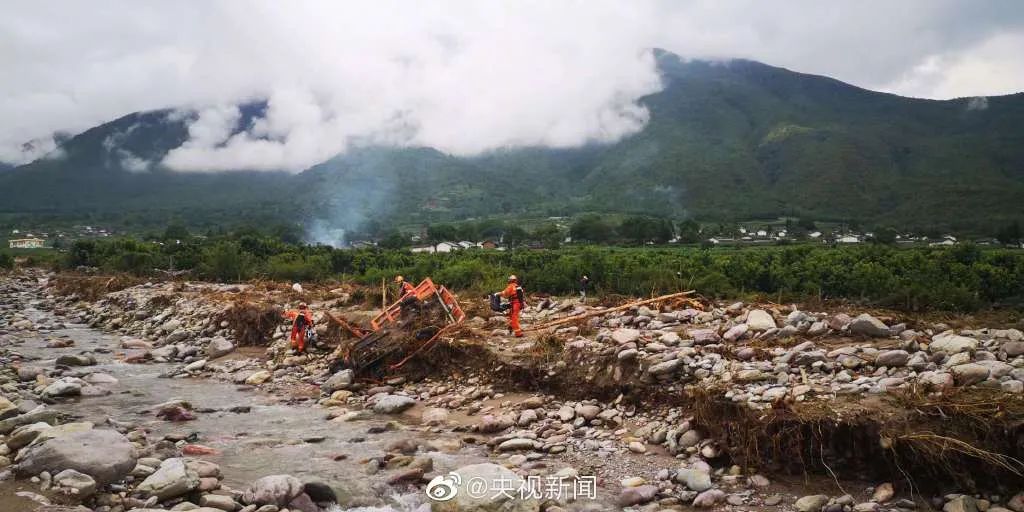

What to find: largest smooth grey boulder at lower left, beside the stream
left=14, top=430, right=138, bottom=485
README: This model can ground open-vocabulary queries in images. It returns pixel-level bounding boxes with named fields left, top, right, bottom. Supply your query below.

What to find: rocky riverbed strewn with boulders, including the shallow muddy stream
left=0, top=272, right=1024, bottom=512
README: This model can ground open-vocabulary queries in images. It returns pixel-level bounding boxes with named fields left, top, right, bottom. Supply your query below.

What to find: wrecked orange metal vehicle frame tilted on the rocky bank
left=328, top=278, right=466, bottom=373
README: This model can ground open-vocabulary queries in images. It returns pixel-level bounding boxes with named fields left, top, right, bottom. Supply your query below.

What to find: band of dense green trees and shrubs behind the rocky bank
left=63, top=233, right=1024, bottom=311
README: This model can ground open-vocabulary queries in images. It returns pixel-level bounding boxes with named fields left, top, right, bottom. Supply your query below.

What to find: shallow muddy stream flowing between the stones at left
left=0, top=296, right=485, bottom=511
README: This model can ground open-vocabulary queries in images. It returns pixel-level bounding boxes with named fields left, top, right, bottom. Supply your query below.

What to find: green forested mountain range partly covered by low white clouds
left=0, top=51, right=1024, bottom=228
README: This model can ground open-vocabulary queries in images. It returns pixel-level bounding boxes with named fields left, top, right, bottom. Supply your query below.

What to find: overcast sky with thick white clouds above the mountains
left=0, top=0, right=1024, bottom=167
